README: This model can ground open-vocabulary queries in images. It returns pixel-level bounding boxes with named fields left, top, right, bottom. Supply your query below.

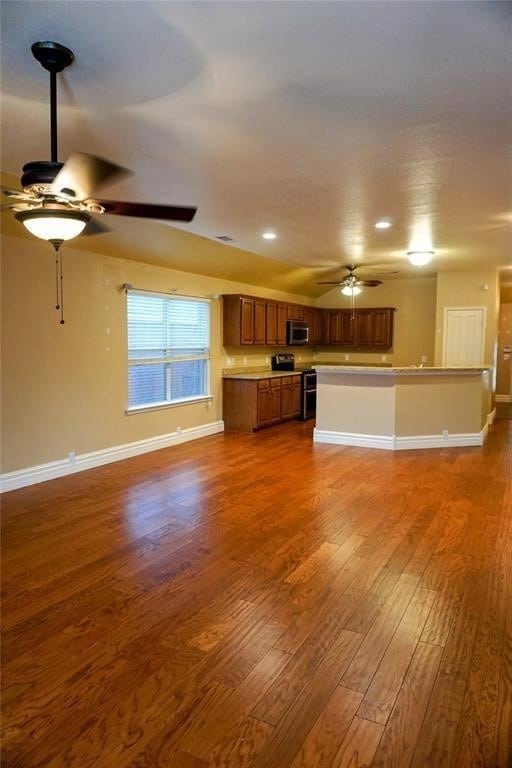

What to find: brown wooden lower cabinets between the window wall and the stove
left=222, top=375, right=300, bottom=432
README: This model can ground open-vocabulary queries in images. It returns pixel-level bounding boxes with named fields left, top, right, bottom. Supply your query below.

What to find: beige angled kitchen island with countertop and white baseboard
left=313, top=365, right=494, bottom=450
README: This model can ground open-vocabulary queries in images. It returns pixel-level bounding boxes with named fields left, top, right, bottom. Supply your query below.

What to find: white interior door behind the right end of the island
left=443, top=307, right=485, bottom=367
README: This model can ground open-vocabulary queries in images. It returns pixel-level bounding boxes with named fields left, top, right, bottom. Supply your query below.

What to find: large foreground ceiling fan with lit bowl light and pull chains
left=2, top=41, right=197, bottom=324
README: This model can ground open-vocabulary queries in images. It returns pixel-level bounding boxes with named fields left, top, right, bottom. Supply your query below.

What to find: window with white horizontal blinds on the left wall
left=127, top=291, right=210, bottom=409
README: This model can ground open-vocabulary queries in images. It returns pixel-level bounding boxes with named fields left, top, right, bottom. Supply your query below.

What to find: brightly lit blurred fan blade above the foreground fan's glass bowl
left=52, top=152, right=132, bottom=200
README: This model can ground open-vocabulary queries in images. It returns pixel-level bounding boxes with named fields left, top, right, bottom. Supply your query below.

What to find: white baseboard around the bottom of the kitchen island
left=313, top=429, right=487, bottom=451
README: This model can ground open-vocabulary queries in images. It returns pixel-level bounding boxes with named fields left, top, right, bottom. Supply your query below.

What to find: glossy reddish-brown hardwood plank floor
left=2, top=420, right=512, bottom=768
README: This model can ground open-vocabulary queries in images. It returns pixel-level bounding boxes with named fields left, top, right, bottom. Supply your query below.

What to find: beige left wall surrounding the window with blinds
left=2, top=237, right=314, bottom=472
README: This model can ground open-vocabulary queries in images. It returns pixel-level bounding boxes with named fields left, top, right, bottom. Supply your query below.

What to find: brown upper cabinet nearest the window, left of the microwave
left=223, top=295, right=267, bottom=347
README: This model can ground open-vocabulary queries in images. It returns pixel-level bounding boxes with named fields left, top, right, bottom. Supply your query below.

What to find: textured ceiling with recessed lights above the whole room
left=1, top=0, right=512, bottom=293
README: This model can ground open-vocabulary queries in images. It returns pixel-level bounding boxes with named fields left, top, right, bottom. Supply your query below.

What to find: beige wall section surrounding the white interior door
left=435, top=269, right=499, bottom=366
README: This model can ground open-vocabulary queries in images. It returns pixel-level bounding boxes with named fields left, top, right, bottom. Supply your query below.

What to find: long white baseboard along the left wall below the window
left=0, top=421, right=224, bottom=492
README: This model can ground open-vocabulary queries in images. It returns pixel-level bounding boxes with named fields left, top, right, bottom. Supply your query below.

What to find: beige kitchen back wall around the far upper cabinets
left=317, top=278, right=436, bottom=365
